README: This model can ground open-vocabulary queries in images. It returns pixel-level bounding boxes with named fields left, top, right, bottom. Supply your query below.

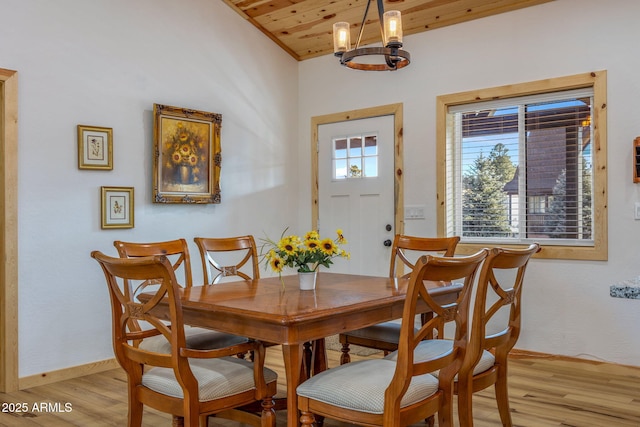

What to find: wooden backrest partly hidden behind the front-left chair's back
left=113, top=239, right=193, bottom=295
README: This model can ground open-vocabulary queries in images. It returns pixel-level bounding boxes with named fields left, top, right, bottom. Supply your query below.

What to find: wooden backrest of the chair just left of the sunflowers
left=193, top=236, right=260, bottom=284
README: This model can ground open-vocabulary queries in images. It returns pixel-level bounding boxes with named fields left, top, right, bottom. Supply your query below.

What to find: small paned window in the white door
left=333, top=135, right=378, bottom=179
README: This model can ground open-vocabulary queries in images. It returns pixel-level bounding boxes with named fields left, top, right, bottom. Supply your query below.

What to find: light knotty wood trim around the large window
left=436, top=71, right=608, bottom=261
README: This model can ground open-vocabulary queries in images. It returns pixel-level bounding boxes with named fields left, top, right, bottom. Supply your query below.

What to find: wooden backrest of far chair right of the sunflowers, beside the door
left=389, top=234, right=460, bottom=277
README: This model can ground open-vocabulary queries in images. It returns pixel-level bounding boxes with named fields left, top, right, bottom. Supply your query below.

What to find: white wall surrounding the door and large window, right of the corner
left=298, top=0, right=640, bottom=365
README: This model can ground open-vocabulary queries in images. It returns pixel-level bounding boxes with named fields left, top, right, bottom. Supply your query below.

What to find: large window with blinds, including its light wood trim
left=438, top=72, right=607, bottom=259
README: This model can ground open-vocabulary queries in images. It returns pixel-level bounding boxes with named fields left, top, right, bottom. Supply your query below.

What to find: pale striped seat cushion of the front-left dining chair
left=142, top=357, right=278, bottom=402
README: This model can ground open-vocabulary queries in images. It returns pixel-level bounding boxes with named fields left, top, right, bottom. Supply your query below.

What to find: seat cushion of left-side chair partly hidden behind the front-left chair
left=140, top=326, right=248, bottom=354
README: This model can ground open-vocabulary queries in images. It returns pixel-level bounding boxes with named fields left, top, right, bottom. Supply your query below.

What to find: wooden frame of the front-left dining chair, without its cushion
left=91, top=251, right=266, bottom=416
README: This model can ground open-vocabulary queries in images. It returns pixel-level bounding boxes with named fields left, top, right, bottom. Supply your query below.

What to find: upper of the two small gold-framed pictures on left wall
left=78, top=125, right=113, bottom=170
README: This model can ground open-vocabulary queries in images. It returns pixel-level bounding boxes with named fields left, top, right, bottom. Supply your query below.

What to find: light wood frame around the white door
left=311, top=103, right=404, bottom=239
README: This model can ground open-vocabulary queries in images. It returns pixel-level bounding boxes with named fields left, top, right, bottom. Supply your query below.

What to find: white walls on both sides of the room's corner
left=0, top=0, right=640, bottom=377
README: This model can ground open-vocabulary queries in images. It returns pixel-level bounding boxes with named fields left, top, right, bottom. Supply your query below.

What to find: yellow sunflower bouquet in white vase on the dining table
left=260, top=229, right=350, bottom=274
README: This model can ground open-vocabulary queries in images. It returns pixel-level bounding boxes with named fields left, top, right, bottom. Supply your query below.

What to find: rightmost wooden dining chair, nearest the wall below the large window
left=454, top=243, right=540, bottom=427
